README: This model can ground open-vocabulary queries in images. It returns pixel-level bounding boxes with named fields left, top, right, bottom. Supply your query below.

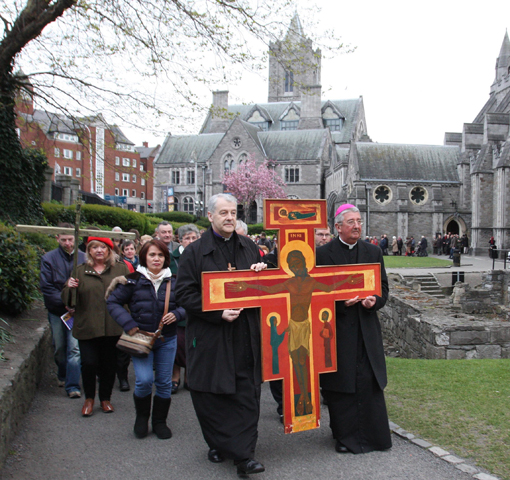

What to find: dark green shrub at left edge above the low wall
left=0, top=224, right=39, bottom=315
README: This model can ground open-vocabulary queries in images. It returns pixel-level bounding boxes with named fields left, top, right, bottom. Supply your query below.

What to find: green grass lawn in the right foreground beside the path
left=385, top=358, right=510, bottom=480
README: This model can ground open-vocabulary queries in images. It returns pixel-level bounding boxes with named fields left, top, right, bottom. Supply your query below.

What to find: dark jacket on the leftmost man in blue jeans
left=39, top=247, right=85, bottom=317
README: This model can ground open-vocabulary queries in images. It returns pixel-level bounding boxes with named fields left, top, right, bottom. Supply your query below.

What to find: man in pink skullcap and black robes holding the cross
left=317, top=204, right=391, bottom=453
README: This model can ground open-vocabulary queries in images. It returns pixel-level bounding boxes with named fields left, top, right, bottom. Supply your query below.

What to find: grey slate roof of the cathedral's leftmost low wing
left=155, top=133, right=225, bottom=165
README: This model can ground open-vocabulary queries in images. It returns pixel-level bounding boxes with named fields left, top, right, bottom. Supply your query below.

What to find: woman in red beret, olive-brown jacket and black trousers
left=62, top=237, right=129, bottom=417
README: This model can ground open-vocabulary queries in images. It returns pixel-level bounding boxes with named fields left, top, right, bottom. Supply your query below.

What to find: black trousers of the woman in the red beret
left=78, top=337, right=119, bottom=402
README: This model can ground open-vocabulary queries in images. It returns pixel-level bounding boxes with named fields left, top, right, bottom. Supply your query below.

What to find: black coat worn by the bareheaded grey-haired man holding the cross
left=175, top=228, right=262, bottom=394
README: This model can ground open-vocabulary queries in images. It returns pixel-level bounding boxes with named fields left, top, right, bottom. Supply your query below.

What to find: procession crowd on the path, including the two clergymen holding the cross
left=41, top=194, right=394, bottom=475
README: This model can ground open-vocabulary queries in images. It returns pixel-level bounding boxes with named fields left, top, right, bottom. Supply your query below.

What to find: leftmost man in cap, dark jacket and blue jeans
left=40, top=223, right=85, bottom=398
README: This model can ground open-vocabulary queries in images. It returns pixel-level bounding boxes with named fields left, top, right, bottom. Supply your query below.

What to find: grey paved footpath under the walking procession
left=0, top=367, right=493, bottom=480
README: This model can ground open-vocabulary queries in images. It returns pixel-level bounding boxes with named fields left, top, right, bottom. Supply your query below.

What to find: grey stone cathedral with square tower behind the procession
left=154, top=14, right=510, bottom=253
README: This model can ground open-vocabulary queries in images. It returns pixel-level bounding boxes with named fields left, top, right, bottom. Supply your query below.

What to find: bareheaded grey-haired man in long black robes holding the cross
left=176, top=194, right=266, bottom=475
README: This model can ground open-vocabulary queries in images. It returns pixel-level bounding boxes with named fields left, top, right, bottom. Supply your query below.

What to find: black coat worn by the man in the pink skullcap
left=316, top=240, right=389, bottom=393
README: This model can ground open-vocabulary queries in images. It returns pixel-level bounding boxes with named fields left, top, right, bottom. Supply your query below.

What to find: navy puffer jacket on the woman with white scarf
left=106, top=272, right=186, bottom=337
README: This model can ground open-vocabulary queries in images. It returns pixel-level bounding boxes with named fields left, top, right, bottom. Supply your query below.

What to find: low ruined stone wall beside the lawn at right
left=379, top=278, right=510, bottom=360
